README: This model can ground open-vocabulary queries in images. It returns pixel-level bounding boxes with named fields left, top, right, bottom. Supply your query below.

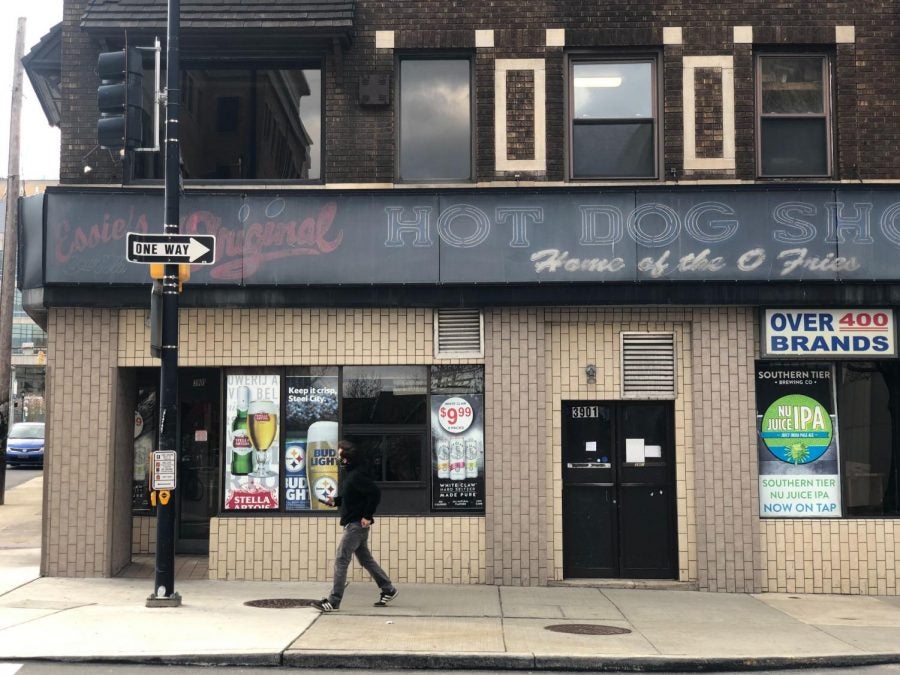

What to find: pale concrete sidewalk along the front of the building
left=0, top=479, right=900, bottom=671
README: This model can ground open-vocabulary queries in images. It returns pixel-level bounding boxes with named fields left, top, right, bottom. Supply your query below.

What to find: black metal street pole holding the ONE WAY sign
left=147, top=0, right=181, bottom=607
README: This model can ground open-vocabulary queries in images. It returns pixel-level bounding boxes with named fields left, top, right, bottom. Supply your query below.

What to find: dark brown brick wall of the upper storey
left=61, top=0, right=900, bottom=183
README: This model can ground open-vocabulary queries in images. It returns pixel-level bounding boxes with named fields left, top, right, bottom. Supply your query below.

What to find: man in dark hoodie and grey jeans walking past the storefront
left=313, top=441, right=400, bottom=612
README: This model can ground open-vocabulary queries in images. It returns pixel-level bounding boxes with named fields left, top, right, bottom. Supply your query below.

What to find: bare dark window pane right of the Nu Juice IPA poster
left=836, top=361, right=900, bottom=517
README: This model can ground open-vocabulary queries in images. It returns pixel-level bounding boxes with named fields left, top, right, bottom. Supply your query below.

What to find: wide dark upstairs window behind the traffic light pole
left=135, top=63, right=323, bottom=181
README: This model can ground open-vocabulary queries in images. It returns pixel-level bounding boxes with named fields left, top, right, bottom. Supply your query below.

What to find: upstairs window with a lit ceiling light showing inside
left=569, top=57, right=659, bottom=179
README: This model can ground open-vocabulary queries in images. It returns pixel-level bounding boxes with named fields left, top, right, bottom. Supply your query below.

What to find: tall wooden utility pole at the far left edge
left=0, top=16, right=25, bottom=504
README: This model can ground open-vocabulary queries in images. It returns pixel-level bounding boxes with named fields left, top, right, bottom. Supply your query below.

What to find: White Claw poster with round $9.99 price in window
left=431, top=394, right=484, bottom=513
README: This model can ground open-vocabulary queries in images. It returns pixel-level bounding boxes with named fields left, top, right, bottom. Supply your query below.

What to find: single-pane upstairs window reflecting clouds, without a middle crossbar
left=397, top=58, right=472, bottom=181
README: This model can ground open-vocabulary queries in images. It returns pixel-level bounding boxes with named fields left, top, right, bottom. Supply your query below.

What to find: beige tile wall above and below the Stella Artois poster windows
left=118, top=309, right=486, bottom=583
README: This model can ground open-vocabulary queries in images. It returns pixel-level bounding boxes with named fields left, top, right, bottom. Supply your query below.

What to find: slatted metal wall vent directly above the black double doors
left=622, top=333, right=675, bottom=398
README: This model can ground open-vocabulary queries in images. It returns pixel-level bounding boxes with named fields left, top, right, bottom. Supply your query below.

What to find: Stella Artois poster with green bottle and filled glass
left=224, top=375, right=281, bottom=511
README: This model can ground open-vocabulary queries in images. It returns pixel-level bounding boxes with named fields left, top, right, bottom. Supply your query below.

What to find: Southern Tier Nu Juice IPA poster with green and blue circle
left=756, top=363, right=841, bottom=518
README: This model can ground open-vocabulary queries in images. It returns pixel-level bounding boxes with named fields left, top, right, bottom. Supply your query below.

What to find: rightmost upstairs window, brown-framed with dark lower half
left=756, top=54, right=831, bottom=177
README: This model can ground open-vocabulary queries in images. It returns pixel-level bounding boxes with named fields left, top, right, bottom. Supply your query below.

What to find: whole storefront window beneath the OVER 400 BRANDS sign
left=756, top=359, right=900, bottom=518
